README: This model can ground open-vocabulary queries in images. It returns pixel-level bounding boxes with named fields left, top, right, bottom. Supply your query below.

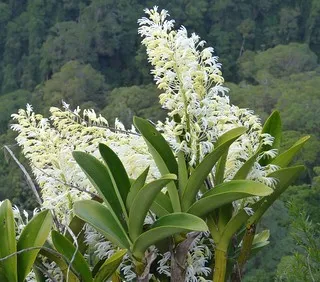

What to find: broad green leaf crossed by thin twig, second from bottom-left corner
left=17, top=210, right=52, bottom=282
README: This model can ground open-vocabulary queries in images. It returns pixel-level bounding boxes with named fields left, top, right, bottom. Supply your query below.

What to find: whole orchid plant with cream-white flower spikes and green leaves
left=0, top=7, right=308, bottom=282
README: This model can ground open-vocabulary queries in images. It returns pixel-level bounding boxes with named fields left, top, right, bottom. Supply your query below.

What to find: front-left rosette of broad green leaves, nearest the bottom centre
left=73, top=144, right=206, bottom=260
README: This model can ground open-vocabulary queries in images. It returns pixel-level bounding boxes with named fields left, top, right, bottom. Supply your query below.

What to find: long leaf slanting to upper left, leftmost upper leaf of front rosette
left=72, top=151, right=127, bottom=227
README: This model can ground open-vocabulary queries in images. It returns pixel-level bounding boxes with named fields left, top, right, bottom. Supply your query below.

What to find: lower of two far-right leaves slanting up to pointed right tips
left=248, top=166, right=304, bottom=225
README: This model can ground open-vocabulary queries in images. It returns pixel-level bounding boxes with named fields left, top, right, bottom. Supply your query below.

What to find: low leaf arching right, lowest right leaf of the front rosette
left=132, top=213, right=208, bottom=258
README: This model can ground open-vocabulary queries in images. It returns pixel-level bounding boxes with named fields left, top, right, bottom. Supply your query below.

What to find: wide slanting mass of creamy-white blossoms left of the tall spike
left=12, top=105, right=158, bottom=224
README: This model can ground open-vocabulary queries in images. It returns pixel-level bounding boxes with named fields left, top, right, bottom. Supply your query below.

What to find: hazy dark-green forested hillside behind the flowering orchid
left=0, top=0, right=320, bottom=282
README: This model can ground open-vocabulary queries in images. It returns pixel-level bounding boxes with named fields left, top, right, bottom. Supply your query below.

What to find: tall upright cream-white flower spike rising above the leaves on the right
left=138, top=7, right=275, bottom=186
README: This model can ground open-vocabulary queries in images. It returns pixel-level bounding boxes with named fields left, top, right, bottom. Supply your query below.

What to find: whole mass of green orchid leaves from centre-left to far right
left=66, top=112, right=308, bottom=281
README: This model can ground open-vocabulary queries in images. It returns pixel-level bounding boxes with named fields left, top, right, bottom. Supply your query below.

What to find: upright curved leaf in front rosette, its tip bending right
left=129, top=174, right=177, bottom=240
